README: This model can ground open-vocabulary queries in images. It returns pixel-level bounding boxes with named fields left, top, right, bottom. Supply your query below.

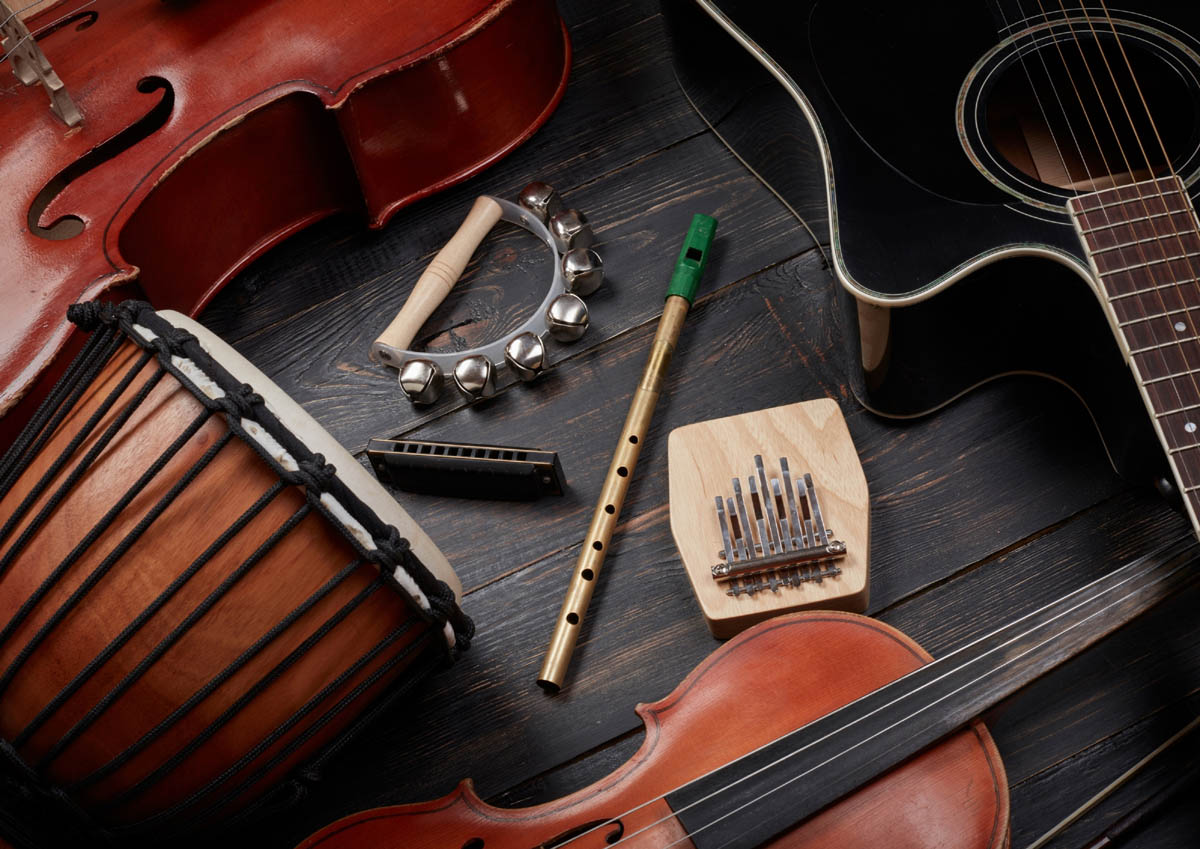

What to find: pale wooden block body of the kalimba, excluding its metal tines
left=667, top=398, right=870, bottom=638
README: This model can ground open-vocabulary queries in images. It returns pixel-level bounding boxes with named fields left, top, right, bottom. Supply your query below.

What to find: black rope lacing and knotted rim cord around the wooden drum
left=0, top=302, right=473, bottom=833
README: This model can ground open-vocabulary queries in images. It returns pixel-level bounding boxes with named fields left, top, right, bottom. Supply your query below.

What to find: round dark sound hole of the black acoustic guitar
left=985, top=20, right=1200, bottom=192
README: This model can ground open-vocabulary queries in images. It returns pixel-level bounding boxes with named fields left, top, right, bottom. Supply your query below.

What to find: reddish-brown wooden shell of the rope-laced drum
left=0, top=304, right=463, bottom=827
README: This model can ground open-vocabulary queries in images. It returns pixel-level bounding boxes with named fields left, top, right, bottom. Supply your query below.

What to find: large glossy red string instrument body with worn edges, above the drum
left=0, top=0, right=570, bottom=430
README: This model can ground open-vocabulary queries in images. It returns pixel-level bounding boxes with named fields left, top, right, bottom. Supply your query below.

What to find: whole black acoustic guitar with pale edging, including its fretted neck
left=666, top=0, right=1200, bottom=528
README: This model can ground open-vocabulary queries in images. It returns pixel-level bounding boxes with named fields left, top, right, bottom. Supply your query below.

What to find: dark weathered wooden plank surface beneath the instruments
left=192, top=0, right=1200, bottom=847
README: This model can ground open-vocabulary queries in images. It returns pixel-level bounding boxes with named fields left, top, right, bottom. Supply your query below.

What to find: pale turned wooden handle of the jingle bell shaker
left=371, top=197, right=502, bottom=362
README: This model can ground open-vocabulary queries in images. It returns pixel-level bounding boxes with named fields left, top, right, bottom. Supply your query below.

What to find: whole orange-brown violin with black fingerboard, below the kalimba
left=292, top=534, right=1198, bottom=849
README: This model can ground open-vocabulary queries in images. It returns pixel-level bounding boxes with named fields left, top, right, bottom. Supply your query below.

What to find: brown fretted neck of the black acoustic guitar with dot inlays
left=1067, top=175, right=1200, bottom=531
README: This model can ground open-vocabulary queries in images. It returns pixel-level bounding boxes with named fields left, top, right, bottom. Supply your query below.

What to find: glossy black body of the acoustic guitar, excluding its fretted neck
left=667, top=0, right=1200, bottom=478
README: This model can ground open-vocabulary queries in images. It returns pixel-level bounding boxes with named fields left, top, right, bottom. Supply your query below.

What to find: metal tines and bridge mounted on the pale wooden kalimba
left=712, top=454, right=846, bottom=597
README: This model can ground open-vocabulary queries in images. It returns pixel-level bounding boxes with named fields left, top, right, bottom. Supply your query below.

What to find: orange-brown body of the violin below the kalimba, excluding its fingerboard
left=298, top=610, right=1009, bottom=849
